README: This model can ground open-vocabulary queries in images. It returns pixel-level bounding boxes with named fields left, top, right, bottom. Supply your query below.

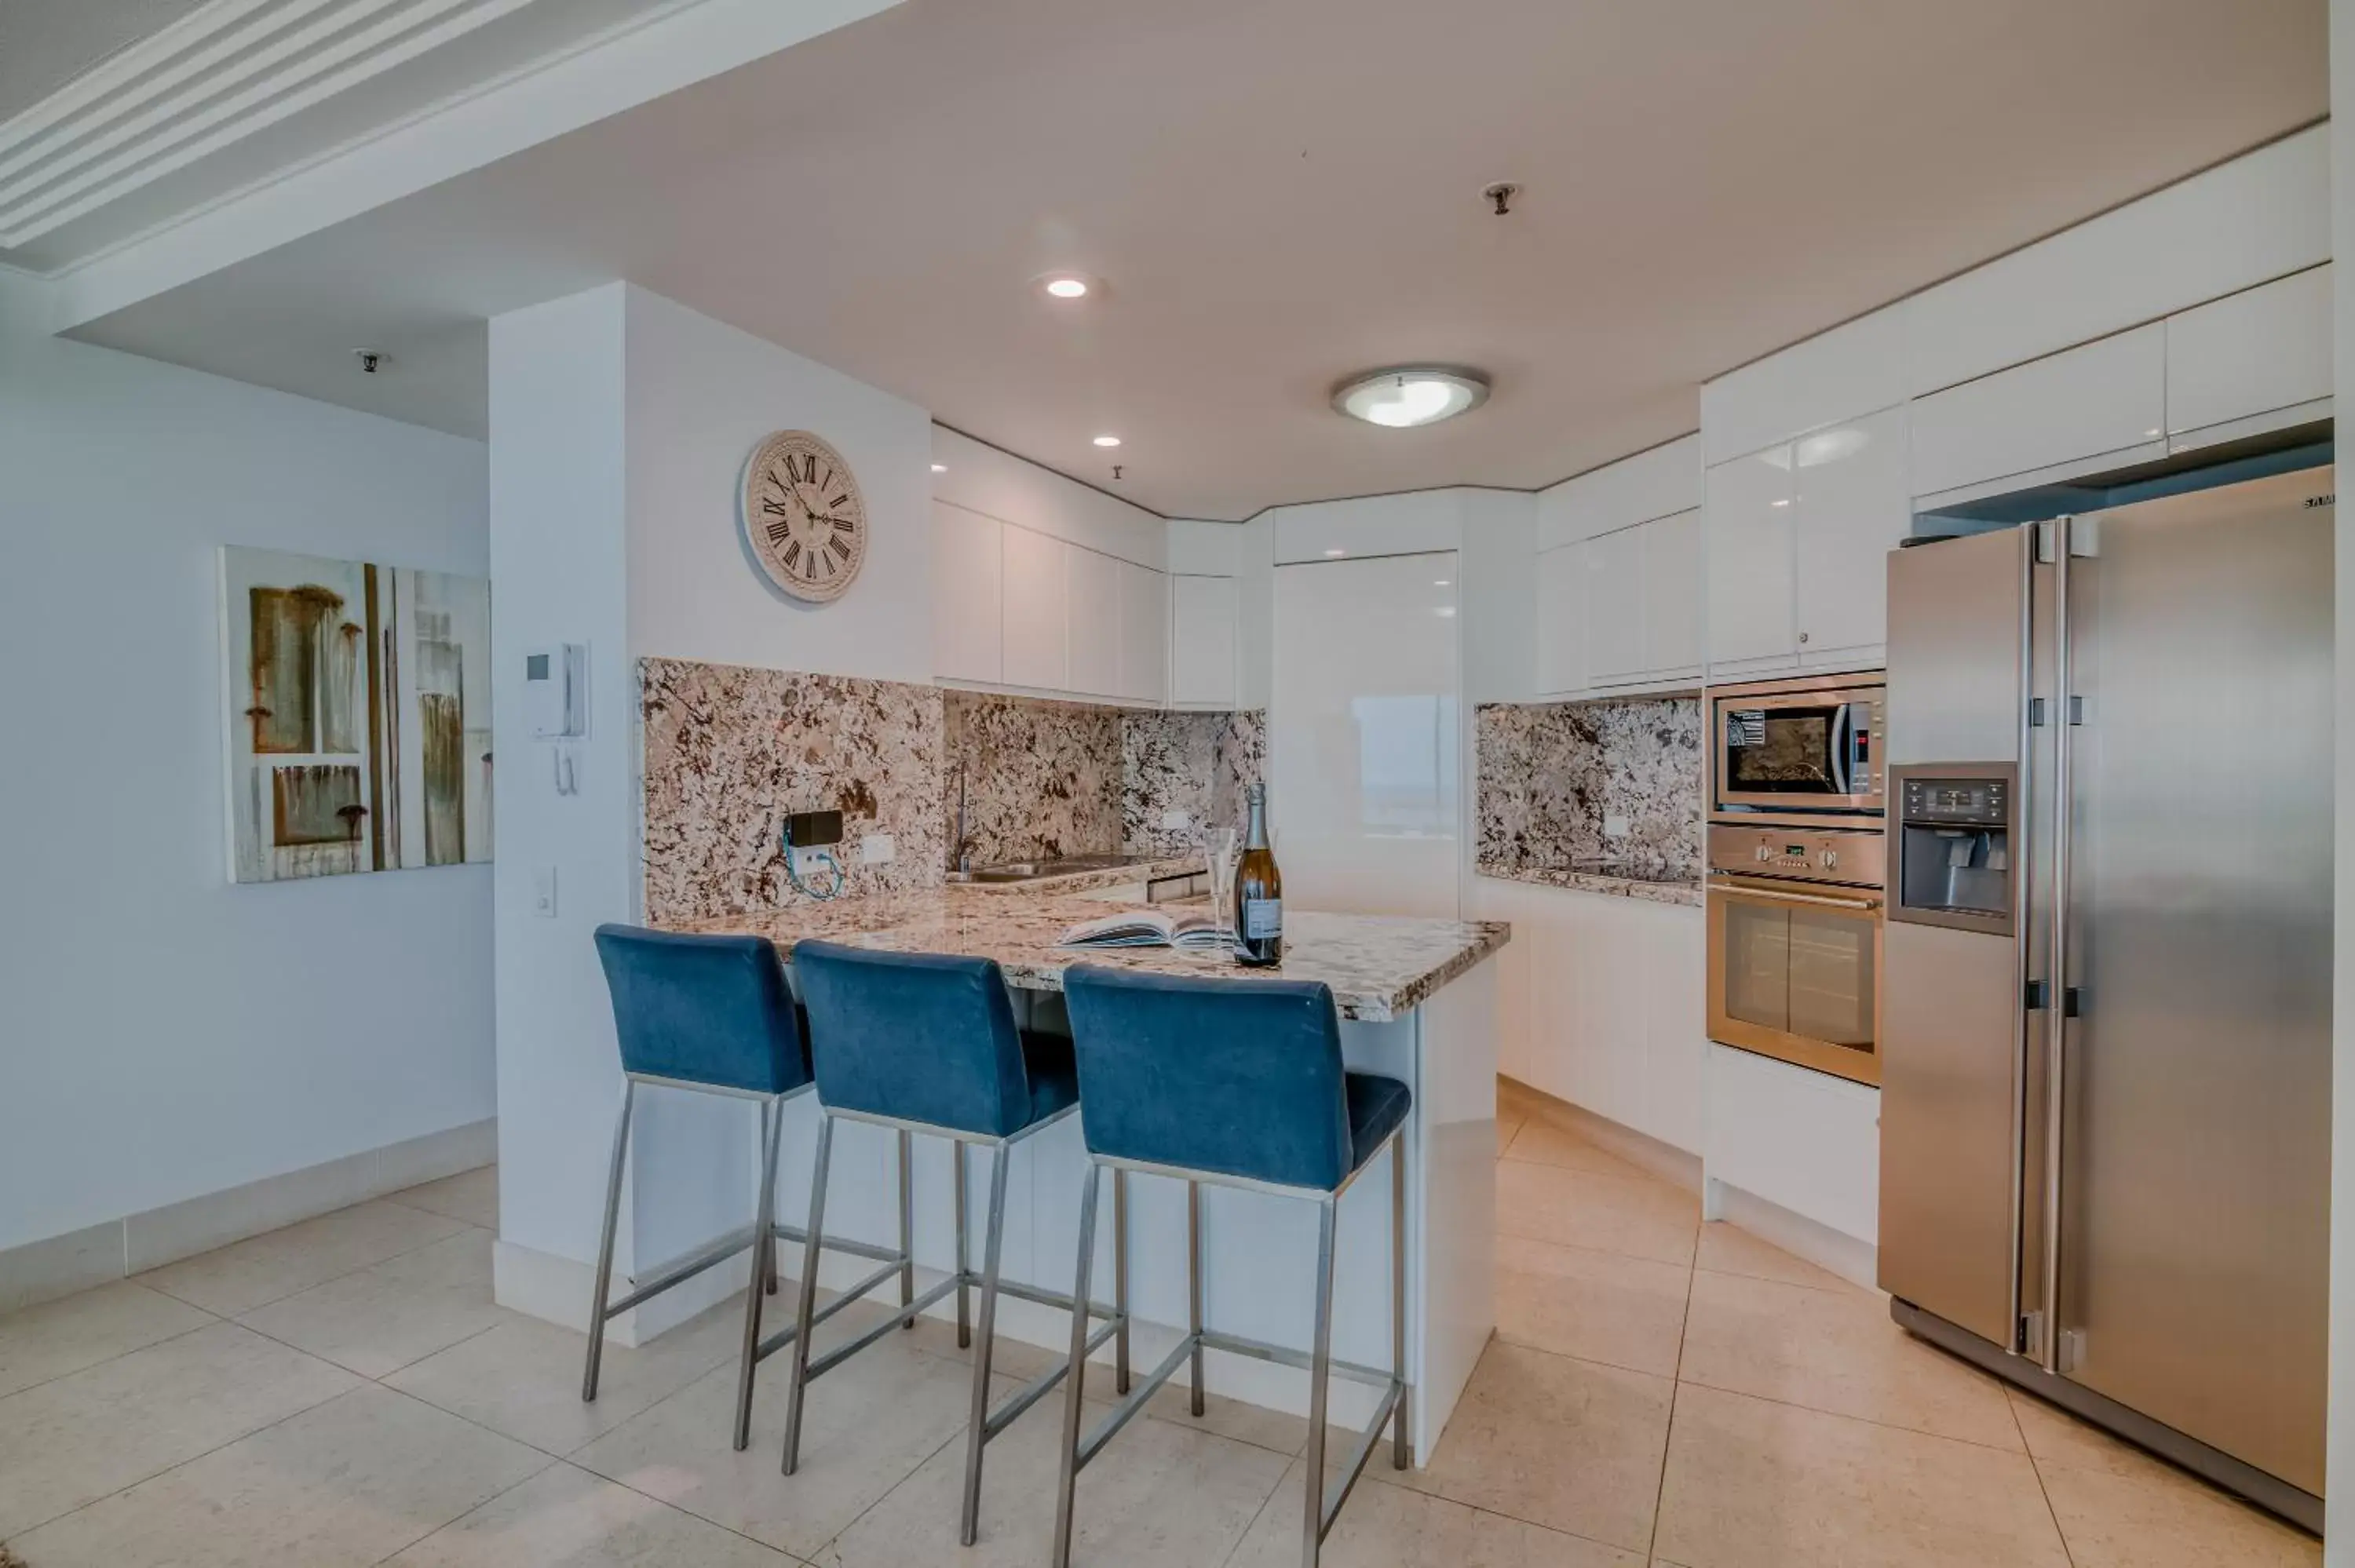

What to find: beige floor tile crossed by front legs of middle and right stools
left=815, top=1384, right=1291, bottom=1568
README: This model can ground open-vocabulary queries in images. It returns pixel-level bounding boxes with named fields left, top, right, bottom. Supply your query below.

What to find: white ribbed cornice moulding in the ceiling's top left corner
left=0, top=0, right=539, bottom=247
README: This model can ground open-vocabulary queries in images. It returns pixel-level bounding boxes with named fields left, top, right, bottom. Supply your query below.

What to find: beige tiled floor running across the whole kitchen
left=0, top=1085, right=2322, bottom=1568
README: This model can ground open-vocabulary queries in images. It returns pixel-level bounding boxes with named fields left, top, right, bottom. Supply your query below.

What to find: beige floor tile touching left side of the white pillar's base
left=238, top=1227, right=504, bottom=1377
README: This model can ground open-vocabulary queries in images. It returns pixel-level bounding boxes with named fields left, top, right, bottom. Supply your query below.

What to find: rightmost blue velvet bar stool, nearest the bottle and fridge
left=1053, top=965, right=1413, bottom=1568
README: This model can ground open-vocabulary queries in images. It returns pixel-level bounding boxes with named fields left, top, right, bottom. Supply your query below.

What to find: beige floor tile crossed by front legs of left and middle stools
left=572, top=1335, right=980, bottom=1556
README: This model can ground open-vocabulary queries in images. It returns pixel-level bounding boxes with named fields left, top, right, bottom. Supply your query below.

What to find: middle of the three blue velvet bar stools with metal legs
left=784, top=942, right=1128, bottom=1547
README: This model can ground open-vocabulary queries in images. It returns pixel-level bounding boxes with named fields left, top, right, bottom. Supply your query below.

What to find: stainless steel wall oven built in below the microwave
left=1707, top=822, right=1886, bottom=1083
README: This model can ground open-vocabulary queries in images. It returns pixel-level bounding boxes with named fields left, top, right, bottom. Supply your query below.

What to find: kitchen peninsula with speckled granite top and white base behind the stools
left=671, top=885, right=1510, bottom=1464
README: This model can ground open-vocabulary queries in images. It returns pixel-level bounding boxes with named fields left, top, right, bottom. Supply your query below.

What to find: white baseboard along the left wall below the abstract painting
left=0, top=1118, right=499, bottom=1311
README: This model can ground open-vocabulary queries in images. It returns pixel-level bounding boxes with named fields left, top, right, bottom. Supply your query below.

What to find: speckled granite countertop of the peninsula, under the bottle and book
left=669, top=885, right=1512, bottom=1022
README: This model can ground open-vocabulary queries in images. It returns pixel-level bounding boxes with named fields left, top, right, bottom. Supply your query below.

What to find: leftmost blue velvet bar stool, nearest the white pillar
left=582, top=925, right=914, bottom=1448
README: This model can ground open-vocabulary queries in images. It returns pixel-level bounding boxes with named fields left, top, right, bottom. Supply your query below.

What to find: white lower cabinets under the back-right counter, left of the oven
left=1474, top=876, right=1707, bottom=1154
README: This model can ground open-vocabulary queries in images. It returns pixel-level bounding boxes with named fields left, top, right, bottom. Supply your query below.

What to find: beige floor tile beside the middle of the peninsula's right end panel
left=1495, top=1236, right=1691, bottom=1377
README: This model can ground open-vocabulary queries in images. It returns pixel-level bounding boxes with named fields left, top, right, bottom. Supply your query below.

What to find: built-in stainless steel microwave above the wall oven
left=1710, top=673, right=1884, bottom=822
